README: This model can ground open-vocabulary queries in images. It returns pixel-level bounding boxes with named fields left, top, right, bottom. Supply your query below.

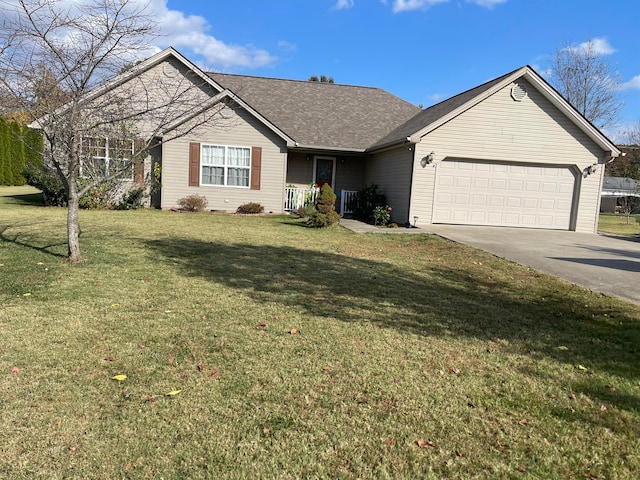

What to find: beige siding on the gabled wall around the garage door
left=410, top=80, right=605, bottom=232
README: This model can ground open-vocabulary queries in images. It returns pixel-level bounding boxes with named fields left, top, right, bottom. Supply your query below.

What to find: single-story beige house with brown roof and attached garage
left=82, top=48, right=620, bottom=232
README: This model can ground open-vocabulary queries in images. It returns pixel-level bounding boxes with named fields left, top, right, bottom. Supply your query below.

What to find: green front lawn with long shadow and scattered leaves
left=0, top=189, right=640, bottom=479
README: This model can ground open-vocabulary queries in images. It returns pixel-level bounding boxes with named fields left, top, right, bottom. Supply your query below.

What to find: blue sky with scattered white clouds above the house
left=156, top=0, right=640, bottom=141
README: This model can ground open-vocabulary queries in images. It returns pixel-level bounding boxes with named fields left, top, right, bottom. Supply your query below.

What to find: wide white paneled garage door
left=433, top=160, right=576, bottom=230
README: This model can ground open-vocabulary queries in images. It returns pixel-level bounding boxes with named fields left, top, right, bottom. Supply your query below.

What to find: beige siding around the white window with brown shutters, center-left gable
left=162, top=103, right=286, bottom=213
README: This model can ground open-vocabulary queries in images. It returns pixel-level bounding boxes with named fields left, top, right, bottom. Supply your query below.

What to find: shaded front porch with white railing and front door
left=284, top=152, right=366, bottom=216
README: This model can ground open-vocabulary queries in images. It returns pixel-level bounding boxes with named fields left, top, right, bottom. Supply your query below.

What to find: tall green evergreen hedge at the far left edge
left=0, top=117, right=42, bottom=185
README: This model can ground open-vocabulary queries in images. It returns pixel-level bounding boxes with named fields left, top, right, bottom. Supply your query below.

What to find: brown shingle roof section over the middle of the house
left=209, top=73, right=421, bottom=151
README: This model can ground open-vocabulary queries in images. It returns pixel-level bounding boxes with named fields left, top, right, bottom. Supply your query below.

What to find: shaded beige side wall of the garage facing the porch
left=365, top=147, right=413, bottom=224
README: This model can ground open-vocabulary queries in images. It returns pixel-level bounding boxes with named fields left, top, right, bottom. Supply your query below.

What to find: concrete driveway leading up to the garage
left=420, top=225, right=640, bottom=303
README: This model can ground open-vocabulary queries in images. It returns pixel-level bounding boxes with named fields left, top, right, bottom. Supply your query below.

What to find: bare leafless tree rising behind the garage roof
left=551, top=38, right=624, bottom=128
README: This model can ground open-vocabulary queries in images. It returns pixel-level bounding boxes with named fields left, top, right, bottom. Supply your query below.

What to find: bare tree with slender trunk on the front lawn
left=0, top=0, right=229, bottom=263
